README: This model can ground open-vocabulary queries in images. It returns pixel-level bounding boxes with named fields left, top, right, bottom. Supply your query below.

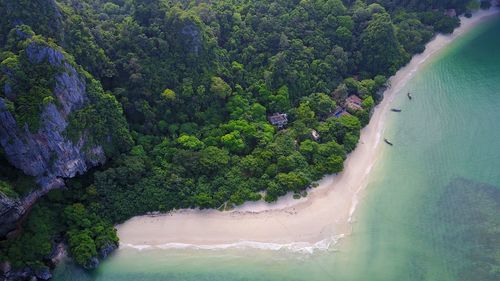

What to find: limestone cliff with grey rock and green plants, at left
left=0, top=26, right=130, bottom=237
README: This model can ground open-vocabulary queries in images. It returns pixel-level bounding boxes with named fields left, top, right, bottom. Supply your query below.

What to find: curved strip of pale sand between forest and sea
left=117, top=9, right=499, bottom=252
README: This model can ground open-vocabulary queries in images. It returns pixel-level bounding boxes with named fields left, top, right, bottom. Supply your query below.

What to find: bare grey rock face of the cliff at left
left=0, top=40, right=106, bottom=237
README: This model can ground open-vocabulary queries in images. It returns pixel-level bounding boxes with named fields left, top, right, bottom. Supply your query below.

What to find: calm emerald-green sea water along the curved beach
left=55, top=17, right=500, bottom=281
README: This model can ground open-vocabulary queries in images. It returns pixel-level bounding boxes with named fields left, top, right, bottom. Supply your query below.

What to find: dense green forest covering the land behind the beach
left=0, top=0, right=479, bottom=274
